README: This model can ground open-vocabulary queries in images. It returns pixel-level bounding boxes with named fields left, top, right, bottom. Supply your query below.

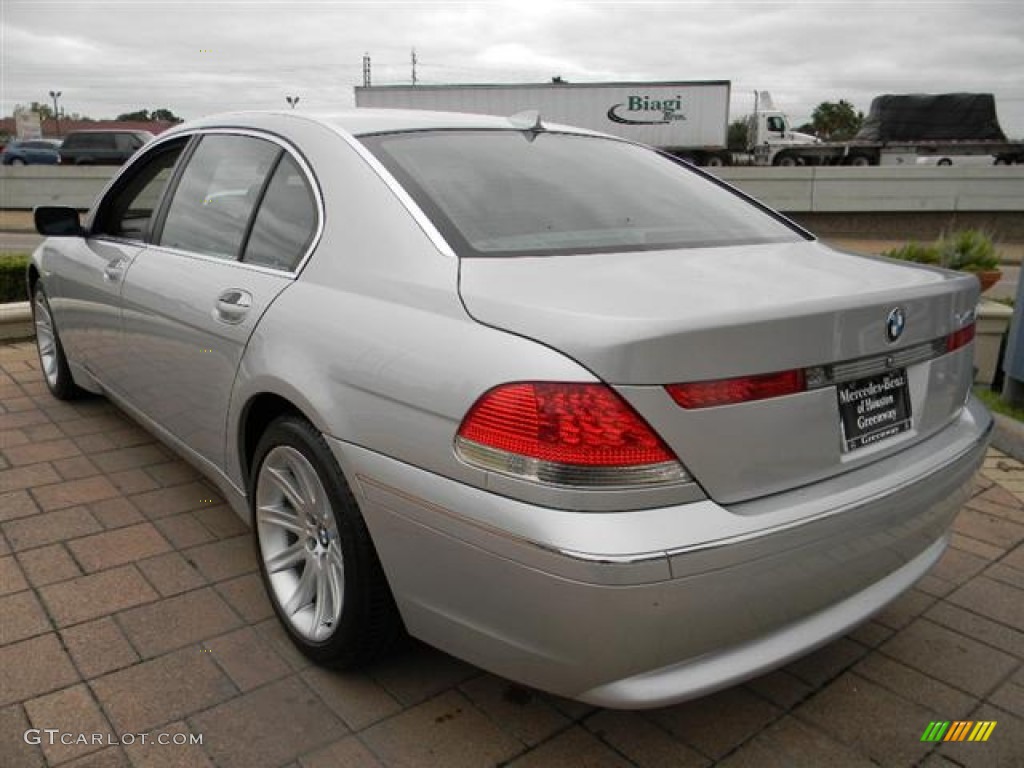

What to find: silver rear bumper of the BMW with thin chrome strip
left=329, top=400, right=991, bottom=709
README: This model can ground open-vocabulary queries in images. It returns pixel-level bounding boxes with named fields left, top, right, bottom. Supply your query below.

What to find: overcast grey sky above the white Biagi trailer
left=0, top=0, right=1024, bottom=137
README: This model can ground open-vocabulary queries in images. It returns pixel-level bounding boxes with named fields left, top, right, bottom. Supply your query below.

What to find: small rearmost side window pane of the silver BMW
left=244, top=155, right=316, bottom=270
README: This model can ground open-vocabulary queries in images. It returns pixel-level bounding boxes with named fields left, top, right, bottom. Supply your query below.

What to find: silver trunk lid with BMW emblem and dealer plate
left=461, top=242, right=978, bottom=503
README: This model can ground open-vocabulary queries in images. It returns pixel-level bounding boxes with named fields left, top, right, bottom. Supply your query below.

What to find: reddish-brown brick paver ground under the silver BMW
left=0, top=343, right=1024, bottom=768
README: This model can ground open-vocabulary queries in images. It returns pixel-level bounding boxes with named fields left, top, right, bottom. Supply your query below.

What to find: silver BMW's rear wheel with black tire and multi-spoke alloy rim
left=249, top=415, right=402, bottom=667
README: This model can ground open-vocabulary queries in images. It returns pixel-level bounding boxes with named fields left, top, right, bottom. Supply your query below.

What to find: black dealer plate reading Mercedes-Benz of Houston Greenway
left=836, top=369, right=910, bottom=451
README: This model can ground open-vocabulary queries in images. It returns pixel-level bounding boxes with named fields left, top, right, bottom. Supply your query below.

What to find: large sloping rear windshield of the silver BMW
left=362, top=130, right=802, bottom=256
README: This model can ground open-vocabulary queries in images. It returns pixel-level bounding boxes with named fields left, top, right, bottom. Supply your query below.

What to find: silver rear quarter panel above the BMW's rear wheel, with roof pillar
left=227, top=118, right=593, bottom=499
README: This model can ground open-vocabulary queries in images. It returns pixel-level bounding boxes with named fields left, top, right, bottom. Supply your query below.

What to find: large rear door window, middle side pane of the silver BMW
left=160, top=134, right=282, bottom=259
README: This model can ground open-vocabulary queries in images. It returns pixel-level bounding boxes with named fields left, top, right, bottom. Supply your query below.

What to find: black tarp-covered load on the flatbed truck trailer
left=856, top=93, right=1007, bottom=141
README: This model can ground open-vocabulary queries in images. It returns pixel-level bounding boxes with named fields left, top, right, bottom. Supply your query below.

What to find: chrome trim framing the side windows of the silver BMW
left=87, top=127, right=327, bottom=280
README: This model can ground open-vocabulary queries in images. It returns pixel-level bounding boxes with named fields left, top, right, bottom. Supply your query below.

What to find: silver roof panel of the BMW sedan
left=167, top=109, right=604, bottom=141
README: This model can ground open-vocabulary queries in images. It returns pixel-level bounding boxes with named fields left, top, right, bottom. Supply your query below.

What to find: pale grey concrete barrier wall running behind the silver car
left=0, top=166, right=1024, bottom=213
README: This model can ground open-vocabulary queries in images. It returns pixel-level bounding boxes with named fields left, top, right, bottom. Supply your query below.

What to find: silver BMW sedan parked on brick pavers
left=29, top=111, right=991, bottom=708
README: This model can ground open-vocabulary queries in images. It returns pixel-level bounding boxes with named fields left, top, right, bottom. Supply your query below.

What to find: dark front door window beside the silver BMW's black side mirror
left=92, top=138, right=188, bottom=241
